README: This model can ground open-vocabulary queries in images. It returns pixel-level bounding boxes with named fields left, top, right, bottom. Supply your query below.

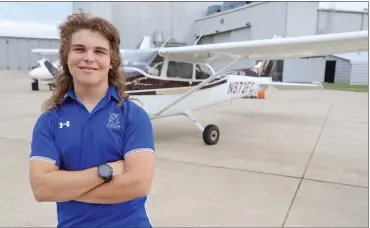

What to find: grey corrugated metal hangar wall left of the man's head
left=0, top=37, right=59, bottom=70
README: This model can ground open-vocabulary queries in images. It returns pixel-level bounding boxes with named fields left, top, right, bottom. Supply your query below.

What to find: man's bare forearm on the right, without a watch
left=76, top=171, right=150, bottom=204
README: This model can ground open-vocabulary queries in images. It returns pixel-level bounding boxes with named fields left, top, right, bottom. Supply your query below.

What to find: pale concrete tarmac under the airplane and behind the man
left=0, top=71, right=369, bottom=227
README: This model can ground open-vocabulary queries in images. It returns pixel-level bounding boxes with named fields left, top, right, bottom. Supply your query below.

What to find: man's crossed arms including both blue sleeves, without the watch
left=29, top=103, right=155, bottom=204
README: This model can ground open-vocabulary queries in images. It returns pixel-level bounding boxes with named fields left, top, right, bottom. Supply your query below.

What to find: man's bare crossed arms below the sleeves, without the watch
left=30, top=152, right=155, bottom=204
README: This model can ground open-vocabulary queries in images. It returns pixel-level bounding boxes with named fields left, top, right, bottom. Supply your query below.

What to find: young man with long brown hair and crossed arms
left=30, top=14, right=155, bottom=227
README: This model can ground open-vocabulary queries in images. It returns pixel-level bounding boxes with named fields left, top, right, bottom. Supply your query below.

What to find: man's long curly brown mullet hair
left=42, top=13, right=128, bottom=112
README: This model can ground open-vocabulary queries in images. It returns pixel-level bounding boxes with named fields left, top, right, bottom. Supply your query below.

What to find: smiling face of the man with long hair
left=67, top=29, right=112, bottom=86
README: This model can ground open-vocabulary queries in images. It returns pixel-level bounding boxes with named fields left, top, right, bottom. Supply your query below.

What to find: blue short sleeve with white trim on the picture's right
left=123, top=103, right=155, bottom=158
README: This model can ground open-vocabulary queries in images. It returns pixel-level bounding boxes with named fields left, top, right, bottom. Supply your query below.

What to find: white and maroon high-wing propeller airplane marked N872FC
left=28, top=31, right=368, bottom=145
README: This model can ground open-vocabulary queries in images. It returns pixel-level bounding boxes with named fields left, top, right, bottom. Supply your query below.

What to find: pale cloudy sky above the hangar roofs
left=0, top=2, right=368, bottom=37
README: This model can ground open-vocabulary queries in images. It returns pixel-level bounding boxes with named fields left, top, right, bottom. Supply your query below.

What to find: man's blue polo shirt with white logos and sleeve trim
left=30, top=86, right=155, bottom=227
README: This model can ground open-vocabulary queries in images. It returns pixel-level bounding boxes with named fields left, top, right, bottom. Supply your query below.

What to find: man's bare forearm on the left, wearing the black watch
left=31, top=168, right=104, bottom=202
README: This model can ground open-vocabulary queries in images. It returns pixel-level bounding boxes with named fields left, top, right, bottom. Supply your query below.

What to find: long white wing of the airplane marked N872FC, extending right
left=159, top=31, right=369, bottom=63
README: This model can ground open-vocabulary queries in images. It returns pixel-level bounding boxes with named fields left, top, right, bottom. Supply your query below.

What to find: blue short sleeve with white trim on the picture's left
left=30, top=114, right=60, bottom=167
